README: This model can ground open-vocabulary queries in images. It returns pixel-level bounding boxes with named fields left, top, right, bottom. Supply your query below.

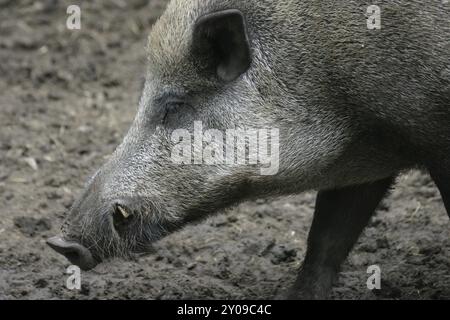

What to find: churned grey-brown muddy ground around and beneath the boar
left=0, top=0, right=450, bottom=299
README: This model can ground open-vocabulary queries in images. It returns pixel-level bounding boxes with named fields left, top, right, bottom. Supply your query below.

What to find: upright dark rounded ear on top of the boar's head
left=193, top=9, right=251, bottom=82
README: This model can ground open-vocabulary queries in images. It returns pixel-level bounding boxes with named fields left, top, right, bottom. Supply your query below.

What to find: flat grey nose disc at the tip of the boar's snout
left=47, top=237, right=99, bottom=271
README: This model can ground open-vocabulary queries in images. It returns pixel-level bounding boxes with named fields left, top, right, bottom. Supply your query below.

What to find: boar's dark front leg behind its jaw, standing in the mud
left=288, top=178, right=394, bottom=299
